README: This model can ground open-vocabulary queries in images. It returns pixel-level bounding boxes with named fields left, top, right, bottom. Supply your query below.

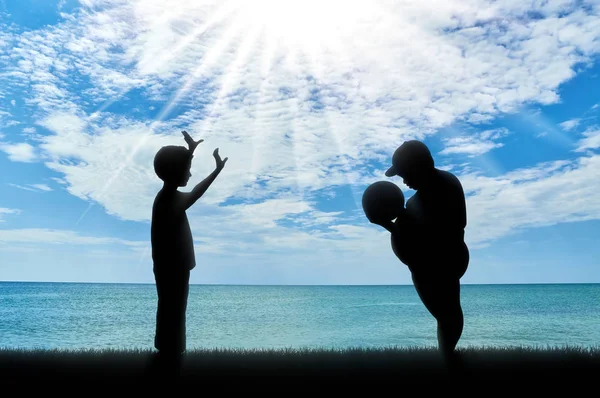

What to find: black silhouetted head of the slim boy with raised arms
left=154, top=145, right=193, bottom=187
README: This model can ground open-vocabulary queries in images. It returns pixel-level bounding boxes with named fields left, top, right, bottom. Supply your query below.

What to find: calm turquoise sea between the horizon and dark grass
left=0, top=282, right=600, bottom=349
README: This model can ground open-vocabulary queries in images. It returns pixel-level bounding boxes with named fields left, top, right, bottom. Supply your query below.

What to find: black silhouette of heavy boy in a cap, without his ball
left=375, top=140, right=469, bottom=358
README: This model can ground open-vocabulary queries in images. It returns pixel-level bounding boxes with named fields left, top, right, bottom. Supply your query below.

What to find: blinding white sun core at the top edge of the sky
left=233, top=0, right=373, bottom=50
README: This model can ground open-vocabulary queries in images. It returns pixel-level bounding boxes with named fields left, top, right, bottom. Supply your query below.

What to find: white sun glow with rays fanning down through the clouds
left=77, top=0, right=408, bottom=223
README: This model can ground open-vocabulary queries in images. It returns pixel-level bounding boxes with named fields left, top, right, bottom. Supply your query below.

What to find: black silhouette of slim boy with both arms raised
left=151, top=131, right=227, bottom=354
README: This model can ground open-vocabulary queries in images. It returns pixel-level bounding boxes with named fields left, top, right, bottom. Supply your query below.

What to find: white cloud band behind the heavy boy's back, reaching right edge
left=460, top=155, right=600, bottom=246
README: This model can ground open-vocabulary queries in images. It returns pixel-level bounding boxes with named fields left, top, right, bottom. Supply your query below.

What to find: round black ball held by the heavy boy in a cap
left=362, top=181, right=404, bottom=221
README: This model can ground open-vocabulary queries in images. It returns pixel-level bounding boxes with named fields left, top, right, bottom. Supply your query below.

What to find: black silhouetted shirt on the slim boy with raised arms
left=151, top=190, right=196, bottom=271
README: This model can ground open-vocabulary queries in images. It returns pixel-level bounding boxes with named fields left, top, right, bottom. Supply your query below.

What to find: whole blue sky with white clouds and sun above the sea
left=0, top=0, right=600, bottom=285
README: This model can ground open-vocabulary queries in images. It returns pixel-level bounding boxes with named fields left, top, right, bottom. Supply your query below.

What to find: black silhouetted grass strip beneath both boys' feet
left=0, top=346, right=600, bottom=394
